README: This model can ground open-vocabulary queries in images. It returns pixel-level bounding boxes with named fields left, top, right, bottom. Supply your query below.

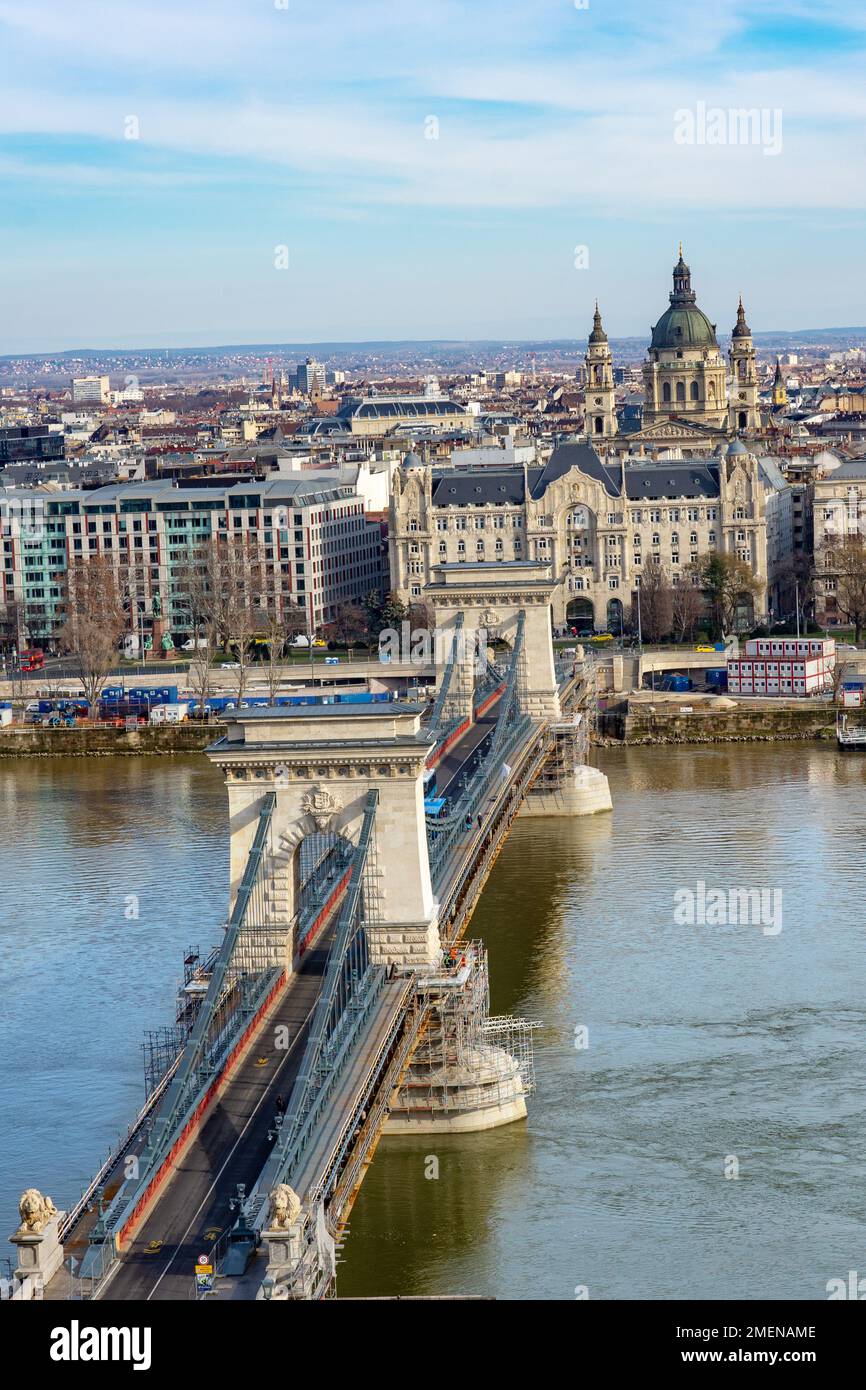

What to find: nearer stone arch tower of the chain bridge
left=209, top=705, right=439, bottom=970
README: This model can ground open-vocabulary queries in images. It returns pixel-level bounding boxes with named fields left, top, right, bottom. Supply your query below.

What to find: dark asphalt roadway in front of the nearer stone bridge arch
left=100, top=931, right=331, bottom=1300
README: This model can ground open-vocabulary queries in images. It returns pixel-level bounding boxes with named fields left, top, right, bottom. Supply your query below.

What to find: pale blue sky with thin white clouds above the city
left=0, top=0, right=866, bottom=353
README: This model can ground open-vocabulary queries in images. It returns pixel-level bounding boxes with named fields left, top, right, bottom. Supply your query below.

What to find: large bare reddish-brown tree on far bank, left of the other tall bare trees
left=60, top=555, right=126, bottom=712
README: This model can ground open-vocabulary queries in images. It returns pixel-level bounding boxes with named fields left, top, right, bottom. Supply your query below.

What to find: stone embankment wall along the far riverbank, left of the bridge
left=0, top=723, right=225, bottom=758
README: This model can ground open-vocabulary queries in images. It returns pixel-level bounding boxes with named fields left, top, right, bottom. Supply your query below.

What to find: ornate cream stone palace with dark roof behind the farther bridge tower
left=389, top=439, right=792, bottom=627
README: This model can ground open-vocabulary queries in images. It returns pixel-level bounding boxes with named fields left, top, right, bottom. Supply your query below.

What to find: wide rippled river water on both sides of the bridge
left=0, top=744, right=866, bottom=1298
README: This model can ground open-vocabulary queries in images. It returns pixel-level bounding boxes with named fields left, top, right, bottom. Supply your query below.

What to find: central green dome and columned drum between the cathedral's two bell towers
left=644, top=245, right=728, bottom=431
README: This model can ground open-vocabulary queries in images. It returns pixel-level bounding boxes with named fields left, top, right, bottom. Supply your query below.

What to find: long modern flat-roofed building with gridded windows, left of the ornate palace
left=0, top=474, right=386, bottom=641
